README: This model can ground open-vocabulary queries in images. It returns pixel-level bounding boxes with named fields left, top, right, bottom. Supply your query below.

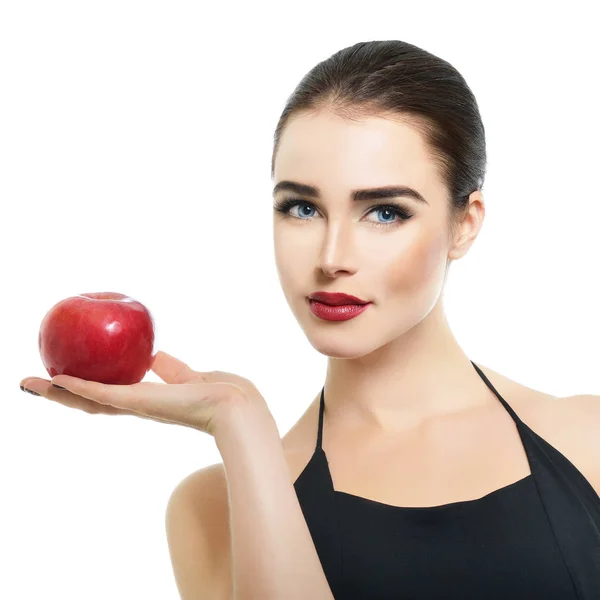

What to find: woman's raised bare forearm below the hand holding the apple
left=215, top=400, right=333, bottom=600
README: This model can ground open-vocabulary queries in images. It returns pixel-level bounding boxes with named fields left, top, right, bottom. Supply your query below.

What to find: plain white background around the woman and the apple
left=0, top=0, right=600, bottom=600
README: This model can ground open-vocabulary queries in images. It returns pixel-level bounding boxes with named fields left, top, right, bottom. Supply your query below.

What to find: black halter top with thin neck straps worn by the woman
left=294, top=361, right=600, bottom=600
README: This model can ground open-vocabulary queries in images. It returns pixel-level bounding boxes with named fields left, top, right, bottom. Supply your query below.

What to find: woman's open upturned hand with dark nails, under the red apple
left=21, top=350, right=270, bottom=436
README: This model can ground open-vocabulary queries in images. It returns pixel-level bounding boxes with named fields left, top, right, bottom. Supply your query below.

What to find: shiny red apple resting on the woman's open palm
left=38, top=292, right=154, bottom=385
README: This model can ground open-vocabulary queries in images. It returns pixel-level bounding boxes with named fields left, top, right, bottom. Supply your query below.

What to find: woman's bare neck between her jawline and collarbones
left=319, top=302, right=490, bottom=433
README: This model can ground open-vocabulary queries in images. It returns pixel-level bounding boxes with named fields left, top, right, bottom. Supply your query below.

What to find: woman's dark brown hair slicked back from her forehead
left=271, top=40, right=486, bottom=246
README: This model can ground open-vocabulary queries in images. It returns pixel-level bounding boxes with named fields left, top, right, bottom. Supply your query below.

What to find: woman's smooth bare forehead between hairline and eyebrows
left=274, top=111, right=437, bottom=192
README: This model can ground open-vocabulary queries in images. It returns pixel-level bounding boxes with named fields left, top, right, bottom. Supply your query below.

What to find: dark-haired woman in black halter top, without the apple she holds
left=18, top=41, right=600, bottom=600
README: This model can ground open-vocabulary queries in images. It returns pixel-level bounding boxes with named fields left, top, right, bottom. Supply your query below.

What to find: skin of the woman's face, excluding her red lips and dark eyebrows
left=273, top=111, right=460, bottom=358
